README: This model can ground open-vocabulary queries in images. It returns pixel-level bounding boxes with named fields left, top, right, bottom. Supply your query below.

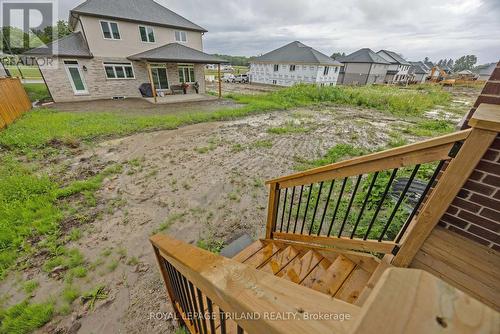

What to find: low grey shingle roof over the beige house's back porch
left=128, top=43, right=227, bottom=64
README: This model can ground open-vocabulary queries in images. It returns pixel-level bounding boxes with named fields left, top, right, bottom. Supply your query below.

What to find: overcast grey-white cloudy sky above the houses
left=59, top=0, right=500, bottom=64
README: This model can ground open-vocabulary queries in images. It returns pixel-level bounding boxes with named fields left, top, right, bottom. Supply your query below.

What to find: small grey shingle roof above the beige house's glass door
left=24, top=32, right=93, bottom=58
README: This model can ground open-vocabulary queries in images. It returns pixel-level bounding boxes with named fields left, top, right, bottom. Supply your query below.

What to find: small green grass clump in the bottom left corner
left=0, top=301, right=54, bottom=334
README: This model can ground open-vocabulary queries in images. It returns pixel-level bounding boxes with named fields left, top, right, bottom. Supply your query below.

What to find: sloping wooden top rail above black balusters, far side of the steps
left=266, top=129, right=471, bottom=188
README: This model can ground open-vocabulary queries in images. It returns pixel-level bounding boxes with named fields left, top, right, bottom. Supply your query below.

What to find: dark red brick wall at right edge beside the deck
left=439, top=63, right=500, bottom=252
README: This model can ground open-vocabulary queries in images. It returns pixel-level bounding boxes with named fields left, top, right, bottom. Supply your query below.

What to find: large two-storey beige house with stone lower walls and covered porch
left=26, top=0, right=225, bottom=102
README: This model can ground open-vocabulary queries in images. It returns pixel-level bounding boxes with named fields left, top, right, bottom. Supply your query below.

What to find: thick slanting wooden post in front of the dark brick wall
left=392, top=104, right=500, bottom=267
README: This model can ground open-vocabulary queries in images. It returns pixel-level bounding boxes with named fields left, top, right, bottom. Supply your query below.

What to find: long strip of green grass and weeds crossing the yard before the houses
left=0, top=85, right=450, bottom=152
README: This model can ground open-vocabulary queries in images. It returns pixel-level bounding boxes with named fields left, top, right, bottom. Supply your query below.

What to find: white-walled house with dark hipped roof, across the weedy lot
left=250, top=41, right=342, bottom=86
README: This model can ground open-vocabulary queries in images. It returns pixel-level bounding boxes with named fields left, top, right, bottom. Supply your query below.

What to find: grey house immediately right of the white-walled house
left=337, top=48, right=390, bottom=85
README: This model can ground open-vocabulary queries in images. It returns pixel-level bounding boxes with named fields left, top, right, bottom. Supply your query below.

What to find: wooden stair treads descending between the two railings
left=233, top=240, right=381, bottom=304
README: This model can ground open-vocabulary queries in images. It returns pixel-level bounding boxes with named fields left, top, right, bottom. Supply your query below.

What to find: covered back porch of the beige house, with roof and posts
left=128, top=43, right=226, bottom=103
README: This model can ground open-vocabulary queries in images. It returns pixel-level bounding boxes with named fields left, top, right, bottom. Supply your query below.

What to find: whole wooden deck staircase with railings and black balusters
left=151, top=98, right=500, bottom=334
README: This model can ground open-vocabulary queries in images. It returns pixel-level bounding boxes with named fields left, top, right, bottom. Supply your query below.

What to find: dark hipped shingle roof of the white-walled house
left=252, top=41, right=342, bottom=66
